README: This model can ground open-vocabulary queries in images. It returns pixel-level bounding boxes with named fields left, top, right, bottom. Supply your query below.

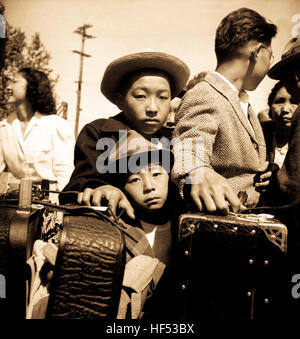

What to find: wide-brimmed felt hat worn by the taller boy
left=101, top=52, right=190, bottom=103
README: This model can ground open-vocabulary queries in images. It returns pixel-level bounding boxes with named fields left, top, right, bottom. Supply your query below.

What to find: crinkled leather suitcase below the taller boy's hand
left=47, top=213, right=125, bottom=319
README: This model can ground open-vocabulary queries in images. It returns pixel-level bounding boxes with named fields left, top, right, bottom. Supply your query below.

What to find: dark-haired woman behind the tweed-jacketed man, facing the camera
left=262, top=81, right=297, bottom=167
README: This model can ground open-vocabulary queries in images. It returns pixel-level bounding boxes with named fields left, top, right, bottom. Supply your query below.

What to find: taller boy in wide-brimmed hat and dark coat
left=60, top=52, right=190, bottom=219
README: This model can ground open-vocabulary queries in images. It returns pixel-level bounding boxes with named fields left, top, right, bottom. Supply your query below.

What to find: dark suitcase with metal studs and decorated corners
left=177, top=213, right=289, bottom=320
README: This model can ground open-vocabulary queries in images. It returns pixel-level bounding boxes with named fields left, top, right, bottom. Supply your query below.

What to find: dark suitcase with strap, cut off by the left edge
left=0, top=200, right=43, bottom=319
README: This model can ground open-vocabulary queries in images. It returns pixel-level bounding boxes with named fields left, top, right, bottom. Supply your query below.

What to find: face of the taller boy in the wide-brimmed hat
left=118, top=74, right=171, bottom=136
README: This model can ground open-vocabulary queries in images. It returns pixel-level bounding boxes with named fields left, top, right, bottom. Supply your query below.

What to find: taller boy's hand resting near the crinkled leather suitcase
left=77, top=185, right=135, bottom=219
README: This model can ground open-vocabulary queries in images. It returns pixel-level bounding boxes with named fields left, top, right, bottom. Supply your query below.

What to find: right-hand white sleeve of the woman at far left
left=52, top=117, right=75, bottom=191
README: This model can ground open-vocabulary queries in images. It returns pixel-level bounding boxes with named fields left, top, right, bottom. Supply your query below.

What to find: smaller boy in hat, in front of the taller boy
left=108, top=130, right=179, bottom=265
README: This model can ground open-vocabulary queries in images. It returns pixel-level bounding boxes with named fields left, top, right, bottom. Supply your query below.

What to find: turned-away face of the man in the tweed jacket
left=243, top=42, right=273, bottom=91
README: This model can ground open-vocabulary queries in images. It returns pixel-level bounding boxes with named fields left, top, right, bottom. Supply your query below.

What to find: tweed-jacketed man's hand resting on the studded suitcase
left=189, top=167, right=245, bottom=214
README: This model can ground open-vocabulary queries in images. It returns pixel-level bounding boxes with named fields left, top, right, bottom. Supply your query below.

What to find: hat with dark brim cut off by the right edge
left=268, top=35, right=300, bottom=80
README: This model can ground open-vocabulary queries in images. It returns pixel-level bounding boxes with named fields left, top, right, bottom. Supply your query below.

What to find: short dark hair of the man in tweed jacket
left=215, top=8, right=277, bottom=63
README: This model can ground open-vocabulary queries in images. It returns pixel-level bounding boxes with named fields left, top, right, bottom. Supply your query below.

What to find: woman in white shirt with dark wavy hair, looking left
left=0, top=67, right=75, bottom=193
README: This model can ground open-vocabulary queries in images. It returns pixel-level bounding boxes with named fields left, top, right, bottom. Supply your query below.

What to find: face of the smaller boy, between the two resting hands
left=124, top=164, right=169, bottom=212
